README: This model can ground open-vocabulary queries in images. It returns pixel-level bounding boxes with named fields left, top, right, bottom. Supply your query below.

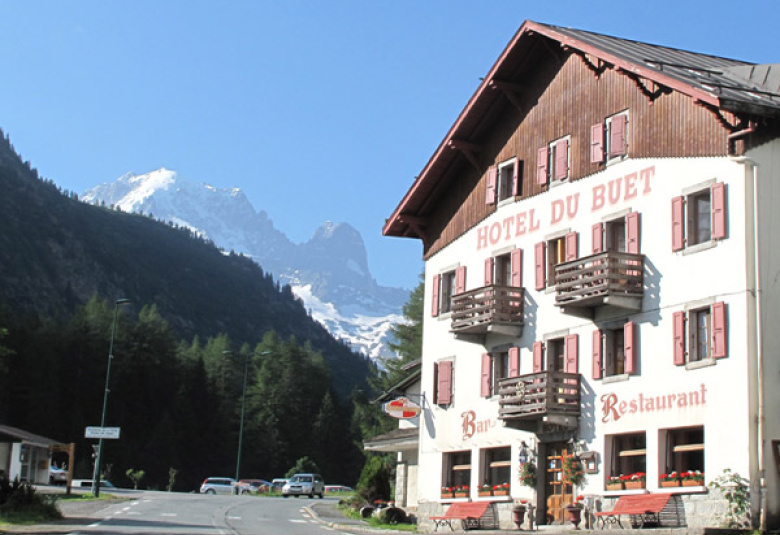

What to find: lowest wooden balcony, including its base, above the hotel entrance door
left=498, top=371, right=580, bottom=434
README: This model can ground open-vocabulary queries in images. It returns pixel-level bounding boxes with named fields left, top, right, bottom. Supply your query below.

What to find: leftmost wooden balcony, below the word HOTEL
left=450, top=285, right=523, bottom=336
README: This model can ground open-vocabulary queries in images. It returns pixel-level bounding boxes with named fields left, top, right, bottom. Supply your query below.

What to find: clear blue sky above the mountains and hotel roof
left=0, top=0, right=780, bottom=294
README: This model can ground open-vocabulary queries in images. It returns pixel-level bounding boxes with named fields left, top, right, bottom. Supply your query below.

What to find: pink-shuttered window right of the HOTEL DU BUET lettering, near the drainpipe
left=672, top=182, right=726, bottom=251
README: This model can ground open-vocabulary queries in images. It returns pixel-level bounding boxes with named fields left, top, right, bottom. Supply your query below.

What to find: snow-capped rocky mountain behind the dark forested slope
left=81, top=168, right=409, bottom=358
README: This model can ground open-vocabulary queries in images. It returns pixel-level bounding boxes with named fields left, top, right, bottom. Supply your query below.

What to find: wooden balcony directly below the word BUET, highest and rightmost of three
left=555, top=252, right=645, bottom=313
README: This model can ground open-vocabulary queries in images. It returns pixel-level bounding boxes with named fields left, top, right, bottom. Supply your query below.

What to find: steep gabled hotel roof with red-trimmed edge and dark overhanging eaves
left=382, top=21, right=780, bottom=237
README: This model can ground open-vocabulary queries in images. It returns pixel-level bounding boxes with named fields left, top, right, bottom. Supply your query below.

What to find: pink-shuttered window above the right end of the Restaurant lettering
left=672, top=302, right=728, bottom=366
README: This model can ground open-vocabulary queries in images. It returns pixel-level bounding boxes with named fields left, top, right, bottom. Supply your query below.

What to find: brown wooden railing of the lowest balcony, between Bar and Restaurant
left=498, top=371, right=580, bottom=420
